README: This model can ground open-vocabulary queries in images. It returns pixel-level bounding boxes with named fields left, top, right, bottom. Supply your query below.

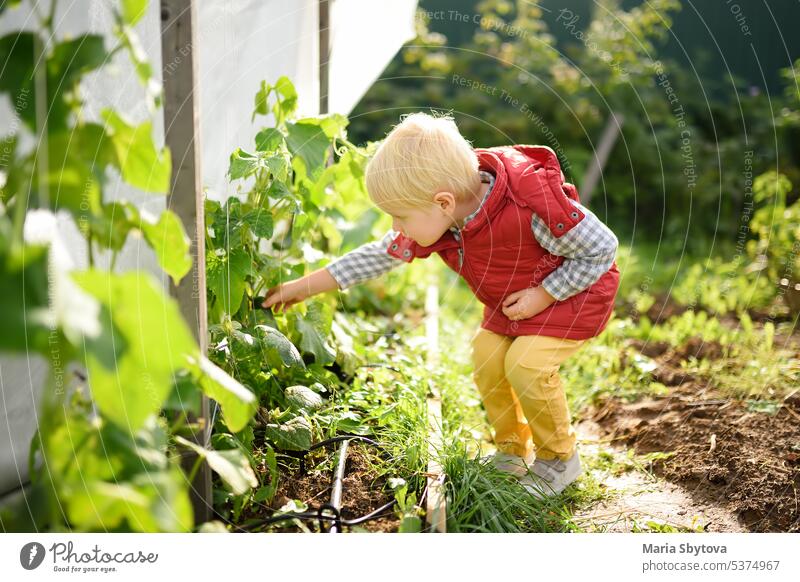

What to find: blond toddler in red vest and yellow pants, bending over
left=263, top=113, right=619, bottom=498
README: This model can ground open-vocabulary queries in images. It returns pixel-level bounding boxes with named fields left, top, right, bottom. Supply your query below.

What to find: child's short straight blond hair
left=366, top=113, right=481, bottom=208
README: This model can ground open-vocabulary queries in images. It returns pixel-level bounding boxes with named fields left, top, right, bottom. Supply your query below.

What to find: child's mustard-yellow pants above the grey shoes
left=472, top=328, right=586, bottom=461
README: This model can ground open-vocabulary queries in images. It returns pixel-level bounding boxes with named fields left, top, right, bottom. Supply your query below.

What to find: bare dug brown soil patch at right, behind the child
left=590, top=384, right=800, bottom=532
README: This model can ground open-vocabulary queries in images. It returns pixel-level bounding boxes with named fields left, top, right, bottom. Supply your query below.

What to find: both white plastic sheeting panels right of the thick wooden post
left=198, top=0, right=417, bottom=199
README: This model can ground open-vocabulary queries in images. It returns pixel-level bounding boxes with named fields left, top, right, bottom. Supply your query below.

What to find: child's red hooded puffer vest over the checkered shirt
left=387, top=145, right=619, bottom=339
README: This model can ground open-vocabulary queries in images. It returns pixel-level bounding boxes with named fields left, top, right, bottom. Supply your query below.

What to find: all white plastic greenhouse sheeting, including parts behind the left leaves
left=0, top=0, right=417, bottom=502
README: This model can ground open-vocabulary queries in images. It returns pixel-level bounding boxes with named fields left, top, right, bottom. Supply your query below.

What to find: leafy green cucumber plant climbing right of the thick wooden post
left=205, top=77, right=390, bottom=518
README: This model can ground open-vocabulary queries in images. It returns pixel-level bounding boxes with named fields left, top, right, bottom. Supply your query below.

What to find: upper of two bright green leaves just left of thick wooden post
left=103, top=109, right=172, bottom=194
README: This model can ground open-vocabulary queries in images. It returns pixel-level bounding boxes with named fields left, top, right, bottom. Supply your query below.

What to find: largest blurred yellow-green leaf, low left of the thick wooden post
left=73, top=270, right=198, bottom=432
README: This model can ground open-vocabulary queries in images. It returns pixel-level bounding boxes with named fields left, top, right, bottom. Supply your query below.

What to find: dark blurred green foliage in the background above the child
left=349, top=0, right=800, bottom=255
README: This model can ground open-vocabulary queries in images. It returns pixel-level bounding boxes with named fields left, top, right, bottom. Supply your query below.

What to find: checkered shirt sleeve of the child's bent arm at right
left=531, top=199, right=619, bottom=301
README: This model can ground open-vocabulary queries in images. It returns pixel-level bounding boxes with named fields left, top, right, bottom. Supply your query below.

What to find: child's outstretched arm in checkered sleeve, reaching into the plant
left=262, top=229, right=404, bottom=312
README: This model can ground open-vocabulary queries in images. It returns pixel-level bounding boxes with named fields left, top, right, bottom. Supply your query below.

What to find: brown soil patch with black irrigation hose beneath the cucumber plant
left=245, top=441, right=400, bottom=532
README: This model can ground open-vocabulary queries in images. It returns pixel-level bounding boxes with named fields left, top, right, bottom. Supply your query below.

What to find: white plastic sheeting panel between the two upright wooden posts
left=197, top=0, right=322, bottom=200
